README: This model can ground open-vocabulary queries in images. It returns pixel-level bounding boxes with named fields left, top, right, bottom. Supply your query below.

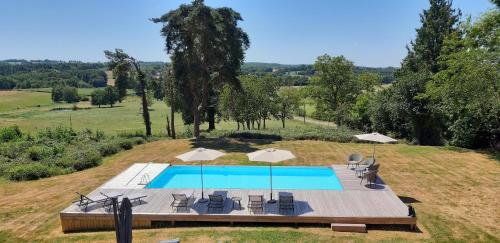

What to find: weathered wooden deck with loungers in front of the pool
left=60, top=165, right=416, bottom=232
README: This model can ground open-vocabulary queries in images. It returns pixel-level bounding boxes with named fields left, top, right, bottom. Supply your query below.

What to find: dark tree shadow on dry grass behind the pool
left=191, top=138, right=272, bottom=153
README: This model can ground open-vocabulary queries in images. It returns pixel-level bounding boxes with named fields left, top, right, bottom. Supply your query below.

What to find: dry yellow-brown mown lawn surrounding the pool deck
left=0, top=139, right=500, bottom=242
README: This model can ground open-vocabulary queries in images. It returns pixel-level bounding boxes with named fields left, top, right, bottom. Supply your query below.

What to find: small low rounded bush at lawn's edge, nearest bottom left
left=5, top=163, right=61, bottom=181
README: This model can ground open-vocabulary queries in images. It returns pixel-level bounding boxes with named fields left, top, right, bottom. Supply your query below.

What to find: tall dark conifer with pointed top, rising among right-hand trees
left=391, top=0, right=461, bottom=145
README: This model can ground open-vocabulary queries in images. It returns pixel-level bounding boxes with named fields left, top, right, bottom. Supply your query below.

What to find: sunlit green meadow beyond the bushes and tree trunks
left=0, top=89, right=306, bottom=134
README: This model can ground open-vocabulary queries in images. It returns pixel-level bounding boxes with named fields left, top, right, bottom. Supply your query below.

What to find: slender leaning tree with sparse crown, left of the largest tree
left=104, top=49, right=151, bottom=136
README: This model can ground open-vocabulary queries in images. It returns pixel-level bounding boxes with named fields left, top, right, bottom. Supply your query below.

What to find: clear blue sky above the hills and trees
left=0, top=0, right=493, bottom=67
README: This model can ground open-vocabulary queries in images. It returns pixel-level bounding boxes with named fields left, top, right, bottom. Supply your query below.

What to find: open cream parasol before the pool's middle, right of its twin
left=247, top=148, right=295, bottom=203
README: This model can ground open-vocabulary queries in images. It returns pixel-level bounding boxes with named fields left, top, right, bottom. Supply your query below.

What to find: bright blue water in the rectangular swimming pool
left=147, top=165, right=342, bottom=190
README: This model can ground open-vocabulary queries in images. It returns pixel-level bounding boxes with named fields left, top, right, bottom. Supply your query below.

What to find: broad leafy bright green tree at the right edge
left=427, top=8, right=500, bottom=149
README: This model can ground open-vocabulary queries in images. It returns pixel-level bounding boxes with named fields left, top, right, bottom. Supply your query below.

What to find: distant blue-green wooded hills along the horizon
left=0, top=59, right=397, bottom=89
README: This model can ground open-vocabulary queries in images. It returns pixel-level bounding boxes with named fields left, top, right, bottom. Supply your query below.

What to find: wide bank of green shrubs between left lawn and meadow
left=0, top=127, right=149, bottom=180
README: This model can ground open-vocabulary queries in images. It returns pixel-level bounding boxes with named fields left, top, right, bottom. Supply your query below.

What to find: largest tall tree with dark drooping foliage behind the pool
left=152, top=0, right=250, bottom=138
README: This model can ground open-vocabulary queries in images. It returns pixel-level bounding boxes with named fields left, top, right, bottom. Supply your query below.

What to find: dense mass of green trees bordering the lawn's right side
left=311, top=0, right=500, bottom=149
